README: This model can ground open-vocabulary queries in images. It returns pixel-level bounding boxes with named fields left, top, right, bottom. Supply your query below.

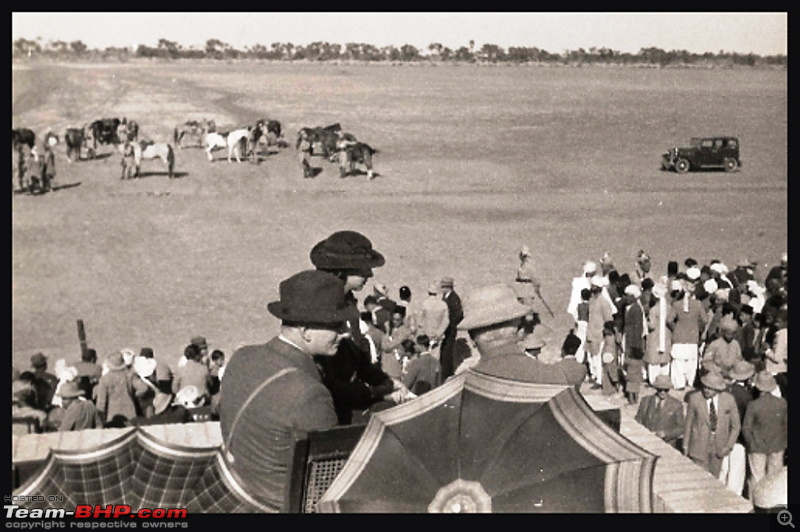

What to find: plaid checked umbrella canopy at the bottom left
left=14, top=428, right=274, bottom=513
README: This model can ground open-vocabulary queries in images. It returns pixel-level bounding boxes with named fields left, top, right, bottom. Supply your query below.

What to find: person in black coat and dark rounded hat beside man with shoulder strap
left=312, top=231, right=402, bottom=425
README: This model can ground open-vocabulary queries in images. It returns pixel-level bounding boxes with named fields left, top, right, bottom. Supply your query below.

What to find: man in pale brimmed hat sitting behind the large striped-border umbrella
left=458, top=283, right=571, bottom=385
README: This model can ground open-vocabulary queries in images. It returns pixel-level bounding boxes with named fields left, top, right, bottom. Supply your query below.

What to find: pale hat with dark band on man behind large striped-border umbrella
left=458, top=283, right=530, bottom=330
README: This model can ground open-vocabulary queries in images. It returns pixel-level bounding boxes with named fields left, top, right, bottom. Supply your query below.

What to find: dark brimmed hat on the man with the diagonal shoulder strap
left=267, top=270, right=353, bottom=324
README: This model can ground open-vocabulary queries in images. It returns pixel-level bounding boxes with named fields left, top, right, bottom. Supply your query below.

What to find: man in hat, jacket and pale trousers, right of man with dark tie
left=742, top=371, right=788, bottom=500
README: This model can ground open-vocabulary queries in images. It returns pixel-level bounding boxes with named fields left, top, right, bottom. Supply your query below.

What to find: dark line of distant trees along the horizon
left=11, top=38, right=787, bottom=67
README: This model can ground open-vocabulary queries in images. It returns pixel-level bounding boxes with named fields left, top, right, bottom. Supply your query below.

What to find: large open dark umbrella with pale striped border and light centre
left=317, top=371, right=657, bottom=513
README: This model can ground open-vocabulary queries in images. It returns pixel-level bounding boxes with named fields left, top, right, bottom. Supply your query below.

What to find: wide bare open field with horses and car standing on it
left=12, top=63, right=788, bottom=367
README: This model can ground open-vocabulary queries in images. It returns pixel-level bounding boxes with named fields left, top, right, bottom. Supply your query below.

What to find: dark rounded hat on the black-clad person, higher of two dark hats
left=310, top=231, right=386, bottom=270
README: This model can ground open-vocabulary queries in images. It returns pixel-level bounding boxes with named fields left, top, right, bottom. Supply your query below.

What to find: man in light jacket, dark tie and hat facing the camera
left=683, top=372, right=741, bottom=478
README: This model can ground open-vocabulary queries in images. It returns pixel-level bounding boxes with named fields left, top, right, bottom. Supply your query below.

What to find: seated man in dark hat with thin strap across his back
left=219, top=270, right=352, bottom=512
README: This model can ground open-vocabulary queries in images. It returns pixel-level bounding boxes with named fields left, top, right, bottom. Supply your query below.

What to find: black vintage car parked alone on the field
left=661, top=137, right=742, bottom=174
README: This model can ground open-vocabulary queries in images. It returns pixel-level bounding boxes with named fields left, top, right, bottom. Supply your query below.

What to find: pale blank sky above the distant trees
left=11, top=13, right=788, bottom=55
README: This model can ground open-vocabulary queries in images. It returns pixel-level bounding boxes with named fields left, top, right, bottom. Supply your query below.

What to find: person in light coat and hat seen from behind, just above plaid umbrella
left=94, top=351, right=136, bottom=427
